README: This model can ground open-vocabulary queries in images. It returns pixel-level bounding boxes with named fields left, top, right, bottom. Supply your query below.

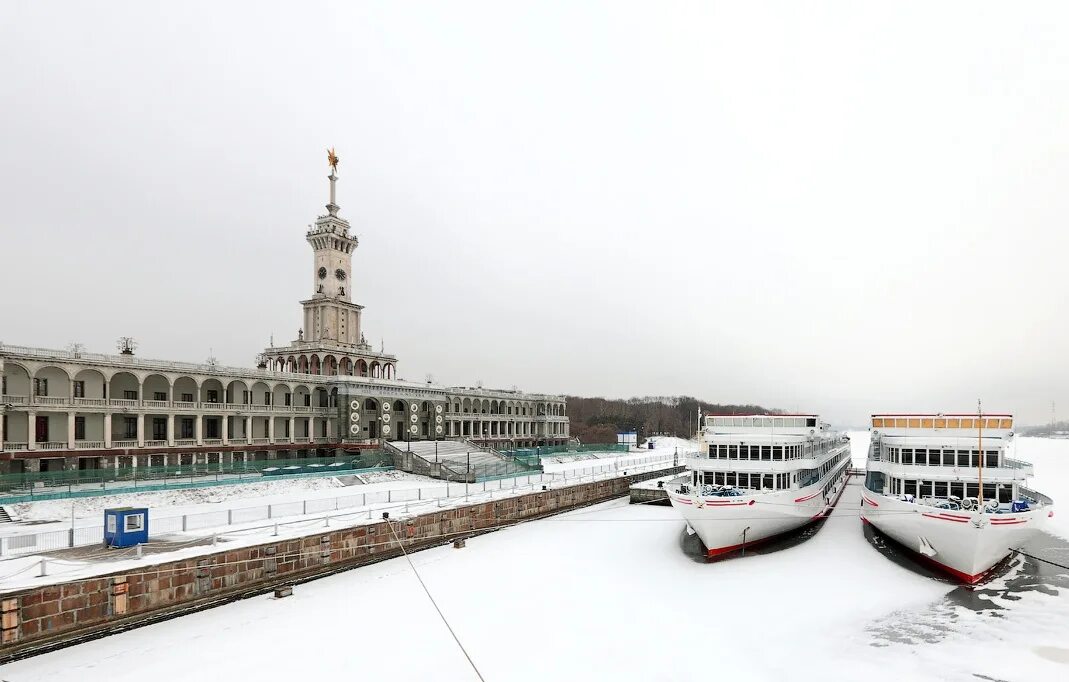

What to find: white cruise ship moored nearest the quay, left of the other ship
left=667, top=415, right=850, bottom=558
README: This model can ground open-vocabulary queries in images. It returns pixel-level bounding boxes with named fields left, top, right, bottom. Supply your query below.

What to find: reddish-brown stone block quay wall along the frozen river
left=0, top=478, right=631, bottom=663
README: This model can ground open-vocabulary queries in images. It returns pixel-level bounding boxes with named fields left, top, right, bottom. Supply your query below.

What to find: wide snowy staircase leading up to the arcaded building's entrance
left=386, top=440, right=541, bottom=483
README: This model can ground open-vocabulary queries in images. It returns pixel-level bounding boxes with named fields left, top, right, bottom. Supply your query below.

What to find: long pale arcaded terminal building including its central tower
left=0, top=165, right=569, bottom=472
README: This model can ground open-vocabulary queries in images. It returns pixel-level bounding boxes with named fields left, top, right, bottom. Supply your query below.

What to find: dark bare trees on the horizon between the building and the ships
left=568, top=396, right=781, bottom=443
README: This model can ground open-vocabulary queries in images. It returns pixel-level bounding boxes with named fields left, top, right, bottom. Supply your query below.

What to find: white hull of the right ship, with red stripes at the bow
left=861, top=490, right=1052, bottom=585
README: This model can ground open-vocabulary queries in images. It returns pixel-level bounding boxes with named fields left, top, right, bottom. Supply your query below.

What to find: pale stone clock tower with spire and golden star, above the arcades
left=300, top=157, right=363, bottom=345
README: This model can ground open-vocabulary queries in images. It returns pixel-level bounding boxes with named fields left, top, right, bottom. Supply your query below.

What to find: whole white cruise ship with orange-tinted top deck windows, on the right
left=862, top=415, right=1054, bottom=584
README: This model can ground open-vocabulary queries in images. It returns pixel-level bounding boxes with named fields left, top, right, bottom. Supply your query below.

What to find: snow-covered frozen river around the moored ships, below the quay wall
left=0, top=443, right=1069, bottom=682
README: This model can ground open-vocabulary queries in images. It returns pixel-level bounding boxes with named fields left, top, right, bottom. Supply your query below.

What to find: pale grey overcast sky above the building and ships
left=0, top=0, right=1069, bottom=423
